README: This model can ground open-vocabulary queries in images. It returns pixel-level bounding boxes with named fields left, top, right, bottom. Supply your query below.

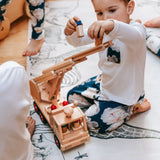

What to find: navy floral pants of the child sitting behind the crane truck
left=67, top=76, right=144, bottom=133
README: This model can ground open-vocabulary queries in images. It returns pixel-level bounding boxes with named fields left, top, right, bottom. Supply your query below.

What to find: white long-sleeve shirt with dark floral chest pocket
left=66, top=20, right=146, bottom=105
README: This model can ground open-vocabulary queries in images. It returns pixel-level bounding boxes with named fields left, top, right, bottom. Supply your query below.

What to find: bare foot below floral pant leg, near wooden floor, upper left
left=22, top=38, right=44, bottom=56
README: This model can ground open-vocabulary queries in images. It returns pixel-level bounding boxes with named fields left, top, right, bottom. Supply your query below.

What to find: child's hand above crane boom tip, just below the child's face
left=88, top=20, right=114, bottom=39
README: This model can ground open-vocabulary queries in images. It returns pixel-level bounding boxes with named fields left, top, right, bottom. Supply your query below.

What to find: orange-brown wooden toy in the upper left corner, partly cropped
left=0, top=0, right=30, bottom=40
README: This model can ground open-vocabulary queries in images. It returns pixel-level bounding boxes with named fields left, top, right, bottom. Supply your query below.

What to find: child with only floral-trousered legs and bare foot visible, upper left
left=0, top=0, right=45, bottom=56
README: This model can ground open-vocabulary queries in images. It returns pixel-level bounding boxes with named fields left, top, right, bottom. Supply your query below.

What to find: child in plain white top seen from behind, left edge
left=0, top=61, right=35, bottom=160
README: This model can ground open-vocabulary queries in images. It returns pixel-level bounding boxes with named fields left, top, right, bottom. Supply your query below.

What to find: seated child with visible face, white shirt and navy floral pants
left=64, top=0, right=150, bottom=133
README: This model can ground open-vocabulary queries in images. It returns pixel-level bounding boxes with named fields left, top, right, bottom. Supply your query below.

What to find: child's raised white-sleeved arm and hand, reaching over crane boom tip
left=88, top=20, right=145, bottom=45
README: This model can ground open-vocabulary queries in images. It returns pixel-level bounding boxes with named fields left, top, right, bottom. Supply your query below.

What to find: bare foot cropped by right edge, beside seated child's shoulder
left=144, top=17, right=160, bottom=28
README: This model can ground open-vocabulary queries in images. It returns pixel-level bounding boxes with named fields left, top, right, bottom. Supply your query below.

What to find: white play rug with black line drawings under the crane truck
left=27, top=0, right=160, bottom=160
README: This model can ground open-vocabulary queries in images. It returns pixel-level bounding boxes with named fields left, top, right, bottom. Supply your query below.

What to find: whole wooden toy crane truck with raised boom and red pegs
left=30, top=42, right=112, bottom=151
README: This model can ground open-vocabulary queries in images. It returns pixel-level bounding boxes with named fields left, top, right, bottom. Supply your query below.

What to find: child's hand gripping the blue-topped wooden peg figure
left=64, top=16, right=80, bottom=36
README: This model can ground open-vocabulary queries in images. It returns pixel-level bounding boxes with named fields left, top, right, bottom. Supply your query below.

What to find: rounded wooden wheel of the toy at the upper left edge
left=0, top=17, right=10, bottom=40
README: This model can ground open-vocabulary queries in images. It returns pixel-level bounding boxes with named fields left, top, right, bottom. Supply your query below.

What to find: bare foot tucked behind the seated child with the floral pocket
left=133, top=98, right=151, bottom=115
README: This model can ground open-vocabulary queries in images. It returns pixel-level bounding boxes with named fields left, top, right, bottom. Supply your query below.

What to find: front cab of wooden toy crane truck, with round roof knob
left=46, top=104, right=90, bottom=151
